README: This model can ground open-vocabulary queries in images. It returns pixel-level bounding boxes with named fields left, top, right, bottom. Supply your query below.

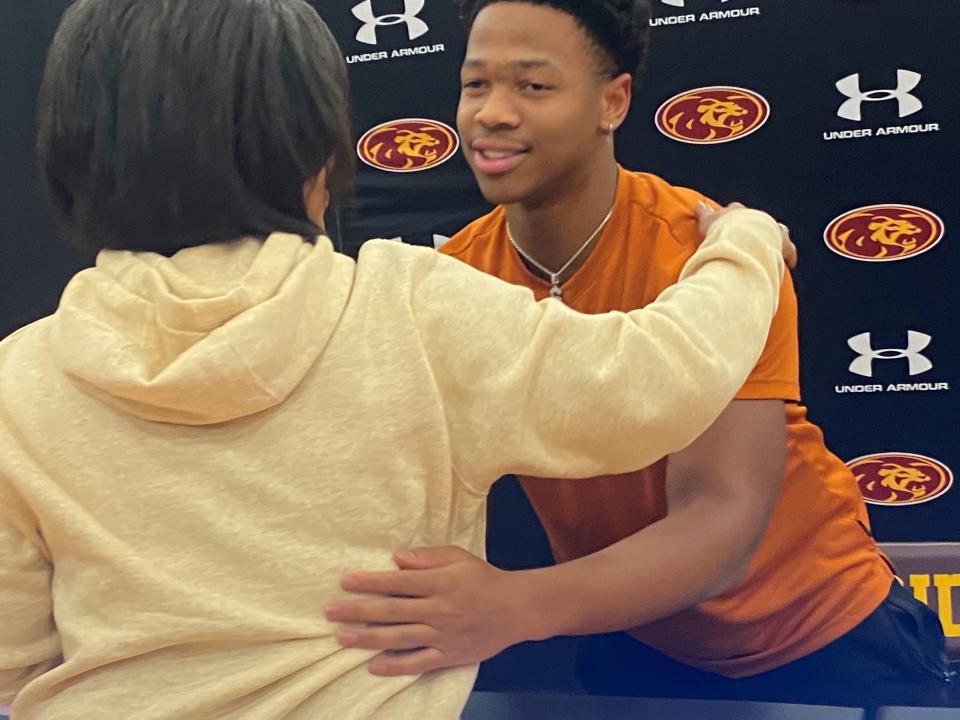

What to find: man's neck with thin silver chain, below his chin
left=506, top=157, right=617, bottom=280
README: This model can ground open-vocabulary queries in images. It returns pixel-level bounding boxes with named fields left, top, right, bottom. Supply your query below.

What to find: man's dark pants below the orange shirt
left=577, top=581, right=952, bottom=708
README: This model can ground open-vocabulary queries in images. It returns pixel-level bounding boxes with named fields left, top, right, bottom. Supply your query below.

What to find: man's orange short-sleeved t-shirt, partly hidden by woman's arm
left=442, top=169, right=893, bottom=678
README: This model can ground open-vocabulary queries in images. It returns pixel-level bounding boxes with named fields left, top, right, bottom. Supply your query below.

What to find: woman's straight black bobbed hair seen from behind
left=37, top=0, right=354, bottom=255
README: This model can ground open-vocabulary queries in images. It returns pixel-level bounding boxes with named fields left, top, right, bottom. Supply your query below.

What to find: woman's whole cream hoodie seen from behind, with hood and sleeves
left=0, top=210, right=782, bottom=720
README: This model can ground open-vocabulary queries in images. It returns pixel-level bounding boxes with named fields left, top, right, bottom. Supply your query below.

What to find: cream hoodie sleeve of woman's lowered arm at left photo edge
left=0, top=486, right=61, bottom=705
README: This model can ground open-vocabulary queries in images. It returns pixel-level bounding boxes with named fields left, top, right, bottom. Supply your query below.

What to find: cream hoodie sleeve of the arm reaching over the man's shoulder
left=414, top=205, right=784, bottom=492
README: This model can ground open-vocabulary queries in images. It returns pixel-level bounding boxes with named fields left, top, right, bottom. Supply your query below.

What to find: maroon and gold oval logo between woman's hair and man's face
left=357, top=118, right=460, bottom=172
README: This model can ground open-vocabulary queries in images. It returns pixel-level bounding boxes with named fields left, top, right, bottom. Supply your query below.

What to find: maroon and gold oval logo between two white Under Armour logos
left=823, top=205, right=944, bottom=262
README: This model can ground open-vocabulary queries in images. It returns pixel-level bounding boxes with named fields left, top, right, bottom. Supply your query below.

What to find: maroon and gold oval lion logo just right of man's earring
left=657, top=87, right=770, bottom=145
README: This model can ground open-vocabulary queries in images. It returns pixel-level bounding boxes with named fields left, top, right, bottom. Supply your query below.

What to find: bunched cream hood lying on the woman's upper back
left=50, top=233, right=353, bottom=425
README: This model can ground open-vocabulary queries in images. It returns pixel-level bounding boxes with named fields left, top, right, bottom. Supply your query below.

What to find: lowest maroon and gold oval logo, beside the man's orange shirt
left=847, top=453, right=953, bottom=505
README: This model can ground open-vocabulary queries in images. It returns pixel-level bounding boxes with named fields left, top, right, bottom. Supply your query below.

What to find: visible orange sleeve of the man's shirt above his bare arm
left=736, top=272, right=800, bottom=402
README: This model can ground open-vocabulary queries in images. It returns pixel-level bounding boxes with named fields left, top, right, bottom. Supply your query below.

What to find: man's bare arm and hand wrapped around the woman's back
left=328, top=400, right=786, bottom=675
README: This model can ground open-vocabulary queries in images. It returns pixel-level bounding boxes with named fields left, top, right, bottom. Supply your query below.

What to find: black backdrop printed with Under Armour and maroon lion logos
left=0, top=0, right=960, bottom=688
